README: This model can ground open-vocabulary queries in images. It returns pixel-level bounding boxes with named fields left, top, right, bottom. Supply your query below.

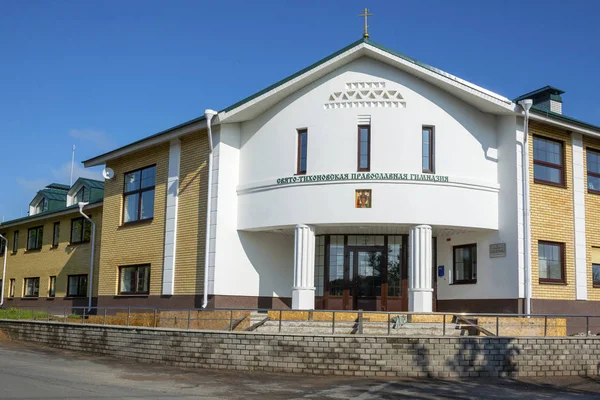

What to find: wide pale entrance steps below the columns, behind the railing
left=248, top=312, right=461, bottom=336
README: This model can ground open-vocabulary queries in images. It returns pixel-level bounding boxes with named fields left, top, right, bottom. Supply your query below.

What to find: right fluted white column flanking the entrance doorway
left=408, top=225, right=433, bottom=312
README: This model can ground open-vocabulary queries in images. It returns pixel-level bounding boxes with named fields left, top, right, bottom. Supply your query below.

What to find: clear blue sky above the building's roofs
left=0, top=0, right=600, bottom=219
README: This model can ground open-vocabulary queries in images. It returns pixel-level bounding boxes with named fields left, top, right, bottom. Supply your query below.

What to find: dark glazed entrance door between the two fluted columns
left=344, top=246, right=386, bottom=311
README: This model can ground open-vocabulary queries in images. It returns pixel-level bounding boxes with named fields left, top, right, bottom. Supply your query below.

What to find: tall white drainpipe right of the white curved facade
left=519, top=99, right=533, bottom=315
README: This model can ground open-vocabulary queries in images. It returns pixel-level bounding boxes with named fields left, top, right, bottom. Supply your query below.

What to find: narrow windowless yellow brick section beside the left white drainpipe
left=175, top=131, right=208, bottom=294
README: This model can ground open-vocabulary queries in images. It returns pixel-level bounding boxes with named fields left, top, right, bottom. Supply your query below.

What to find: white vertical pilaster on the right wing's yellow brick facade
left=571, top=133, right=588, bottom=300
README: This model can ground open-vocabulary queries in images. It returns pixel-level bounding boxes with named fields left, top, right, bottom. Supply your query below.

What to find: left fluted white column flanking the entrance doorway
left=292, top=225, right=315, bottom=310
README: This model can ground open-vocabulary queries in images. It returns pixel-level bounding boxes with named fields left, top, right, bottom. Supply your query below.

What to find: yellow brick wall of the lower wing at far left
left=0, top=205, right=102, bottom=298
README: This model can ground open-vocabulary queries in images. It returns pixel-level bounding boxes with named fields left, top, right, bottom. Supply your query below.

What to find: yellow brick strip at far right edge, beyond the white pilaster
left=583, top=136, right=600, bottom=300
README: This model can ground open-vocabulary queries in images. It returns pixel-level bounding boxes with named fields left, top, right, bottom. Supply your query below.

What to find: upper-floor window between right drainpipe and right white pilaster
left=533, top=136, right=565, bottom=186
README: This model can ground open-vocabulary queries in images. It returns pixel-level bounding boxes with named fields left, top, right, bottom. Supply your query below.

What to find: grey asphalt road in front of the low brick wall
left=0, top=341, right=600, bottom=400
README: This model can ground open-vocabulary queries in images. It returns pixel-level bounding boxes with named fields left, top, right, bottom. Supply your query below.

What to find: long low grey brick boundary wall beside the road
left=0, top=320, right=600, bottom=378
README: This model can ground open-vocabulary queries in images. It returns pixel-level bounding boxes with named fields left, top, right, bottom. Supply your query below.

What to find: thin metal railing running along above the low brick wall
left=0, top=306, right=600, bottom=337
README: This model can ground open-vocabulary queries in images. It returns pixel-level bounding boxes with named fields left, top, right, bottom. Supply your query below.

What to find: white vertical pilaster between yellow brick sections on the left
left=162, top=139, right=181, bottom=296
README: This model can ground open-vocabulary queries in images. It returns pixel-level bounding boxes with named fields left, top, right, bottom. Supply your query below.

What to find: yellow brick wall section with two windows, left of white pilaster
left=98, top=143, right=169, bottom=296
